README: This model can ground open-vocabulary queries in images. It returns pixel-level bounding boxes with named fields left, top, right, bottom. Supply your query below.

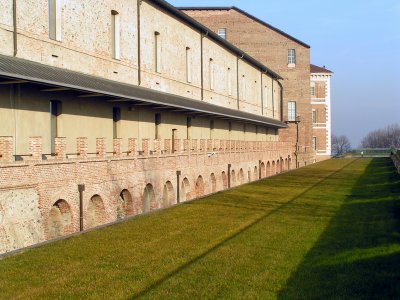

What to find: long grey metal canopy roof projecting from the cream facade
left=0, top=55, right=287, bottom=128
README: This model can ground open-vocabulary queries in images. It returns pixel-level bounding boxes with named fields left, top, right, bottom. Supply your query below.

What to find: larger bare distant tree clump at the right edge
left=361, top=124, right=400, bottom=148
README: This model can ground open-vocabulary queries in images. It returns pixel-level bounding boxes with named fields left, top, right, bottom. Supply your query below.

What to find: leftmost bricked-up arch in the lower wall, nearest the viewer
left=47, top=199, right=74, bottom=239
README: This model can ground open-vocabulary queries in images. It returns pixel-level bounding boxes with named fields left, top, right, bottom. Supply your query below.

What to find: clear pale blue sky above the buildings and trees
left=168, top=0, right=400, bottom=147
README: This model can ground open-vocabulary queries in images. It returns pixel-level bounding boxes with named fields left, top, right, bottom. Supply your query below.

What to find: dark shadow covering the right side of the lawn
left=278, top=158, right=400, bottom=299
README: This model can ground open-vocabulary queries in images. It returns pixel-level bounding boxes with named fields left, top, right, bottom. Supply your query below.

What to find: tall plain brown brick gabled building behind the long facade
left=180, top=6, right=316, bottom=166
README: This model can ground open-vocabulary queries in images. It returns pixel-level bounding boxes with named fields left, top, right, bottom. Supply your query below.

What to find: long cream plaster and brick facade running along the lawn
left=0, top=0, right=296, bottom=253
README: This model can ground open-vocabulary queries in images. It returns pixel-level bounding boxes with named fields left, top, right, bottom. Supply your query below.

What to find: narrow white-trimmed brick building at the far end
left=310, top=64, right=332, bottom=161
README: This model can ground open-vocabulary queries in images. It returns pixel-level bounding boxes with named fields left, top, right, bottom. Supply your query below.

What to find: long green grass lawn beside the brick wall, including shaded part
left=0, top=158, right=400, bottom=299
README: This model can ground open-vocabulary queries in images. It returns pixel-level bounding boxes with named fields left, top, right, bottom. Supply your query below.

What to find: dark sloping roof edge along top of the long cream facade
left=148, top=0, right=283, bottom=80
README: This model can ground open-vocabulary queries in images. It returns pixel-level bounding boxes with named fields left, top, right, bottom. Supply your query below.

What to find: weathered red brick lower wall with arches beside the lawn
left=0, top=137, right=292, bottom=253
